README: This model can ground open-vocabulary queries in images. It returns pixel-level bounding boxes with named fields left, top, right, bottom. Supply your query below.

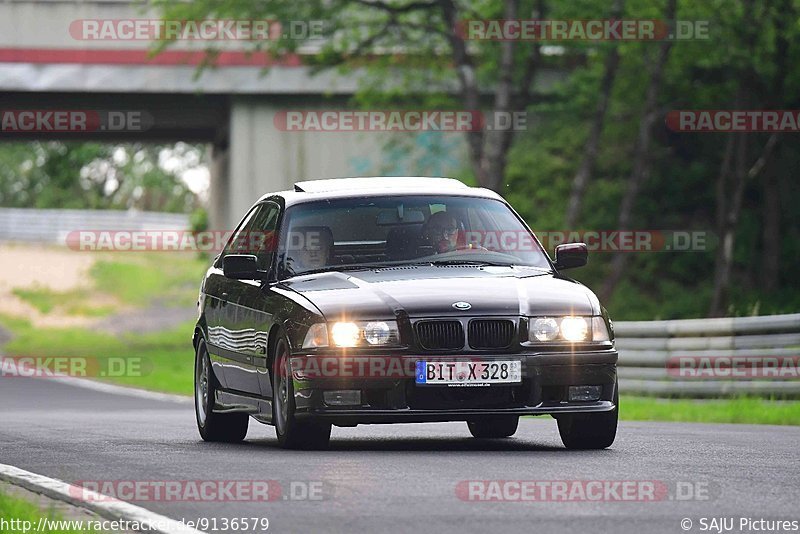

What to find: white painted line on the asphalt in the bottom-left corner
left=0, top=464, right=203, bottom=534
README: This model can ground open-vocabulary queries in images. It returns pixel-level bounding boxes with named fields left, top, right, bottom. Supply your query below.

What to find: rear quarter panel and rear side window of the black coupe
left=205, top=206, right=259, bottom=391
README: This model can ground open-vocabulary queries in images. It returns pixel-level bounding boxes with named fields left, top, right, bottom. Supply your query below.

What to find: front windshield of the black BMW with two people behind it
left=280, top=196, right=550, bottom=278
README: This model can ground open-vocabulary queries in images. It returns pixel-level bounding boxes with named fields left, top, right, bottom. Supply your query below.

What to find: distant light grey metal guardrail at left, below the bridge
left=0, top=208, right=189, bottom=244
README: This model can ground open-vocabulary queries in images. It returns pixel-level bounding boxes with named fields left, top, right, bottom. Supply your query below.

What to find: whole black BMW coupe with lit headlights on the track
left=193, top=177, right=619, bottom=449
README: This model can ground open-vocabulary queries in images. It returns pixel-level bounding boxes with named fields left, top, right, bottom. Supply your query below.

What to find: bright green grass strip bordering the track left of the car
left=0, top=316, right=194, bottom=395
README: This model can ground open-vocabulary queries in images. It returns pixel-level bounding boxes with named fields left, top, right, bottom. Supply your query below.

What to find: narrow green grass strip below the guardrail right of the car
left=620, top=395, right=800, bottom=425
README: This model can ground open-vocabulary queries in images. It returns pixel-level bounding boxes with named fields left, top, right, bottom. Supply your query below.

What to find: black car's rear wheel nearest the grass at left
left=194, top=339, right=250, bottom=443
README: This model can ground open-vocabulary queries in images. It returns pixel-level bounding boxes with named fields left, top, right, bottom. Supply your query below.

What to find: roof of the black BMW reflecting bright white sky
left=259, top=176, right=503, bottom=206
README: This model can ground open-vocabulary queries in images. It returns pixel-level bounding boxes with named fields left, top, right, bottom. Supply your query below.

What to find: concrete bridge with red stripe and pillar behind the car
left=0, top=0, right=560, bottom=228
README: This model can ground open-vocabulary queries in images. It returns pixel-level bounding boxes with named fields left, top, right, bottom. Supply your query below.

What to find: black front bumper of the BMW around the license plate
left=292, top=349, right=618, bottom=426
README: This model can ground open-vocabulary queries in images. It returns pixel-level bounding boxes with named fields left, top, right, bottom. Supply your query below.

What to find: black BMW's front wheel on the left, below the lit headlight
left=272, top=334, right=331, bottom=449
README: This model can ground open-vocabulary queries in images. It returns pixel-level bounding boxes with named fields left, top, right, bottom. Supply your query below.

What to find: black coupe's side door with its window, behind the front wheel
left=226, top=201, right=281, bottom=395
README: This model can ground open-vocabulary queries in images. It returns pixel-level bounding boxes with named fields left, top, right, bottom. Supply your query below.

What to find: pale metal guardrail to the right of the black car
left=614, top=313, right=800, bottom=397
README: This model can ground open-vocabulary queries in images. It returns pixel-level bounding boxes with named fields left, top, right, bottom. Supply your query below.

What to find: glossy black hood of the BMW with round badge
left=284, top=265, right=600, bottom=320
